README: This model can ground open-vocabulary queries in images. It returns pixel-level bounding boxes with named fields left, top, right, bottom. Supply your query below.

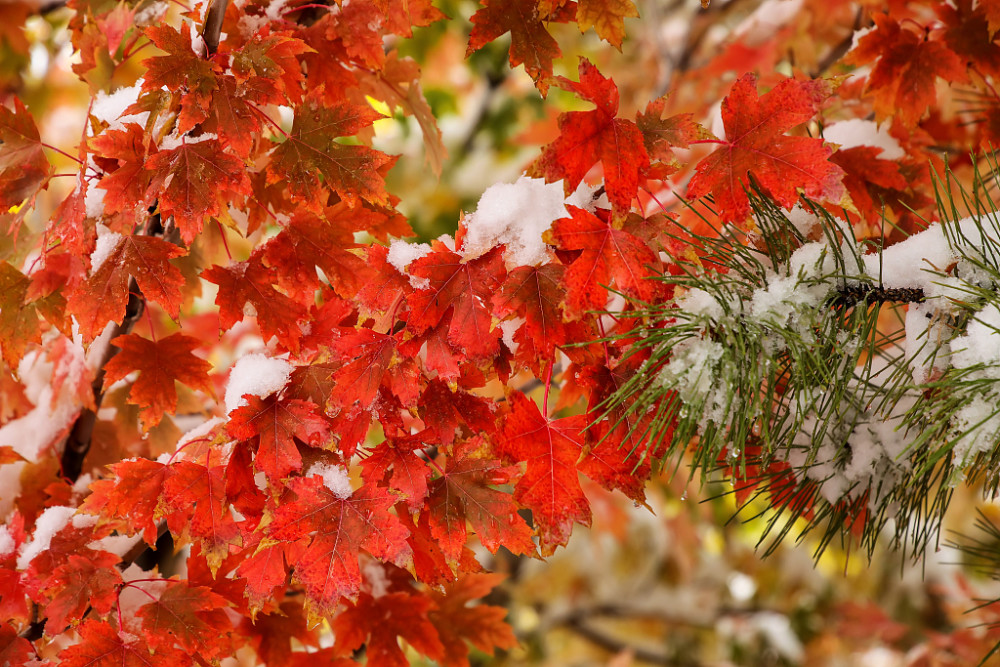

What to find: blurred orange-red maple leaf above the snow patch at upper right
left=845, top=13, right=968, bottom=127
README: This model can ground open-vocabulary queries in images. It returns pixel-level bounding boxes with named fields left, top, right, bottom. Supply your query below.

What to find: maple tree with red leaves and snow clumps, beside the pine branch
left=0, top=0, right=1000, bottom=667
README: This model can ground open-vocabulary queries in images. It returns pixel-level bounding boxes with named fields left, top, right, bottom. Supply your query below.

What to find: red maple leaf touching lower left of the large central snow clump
left=407, top=245, right=504, bottom=359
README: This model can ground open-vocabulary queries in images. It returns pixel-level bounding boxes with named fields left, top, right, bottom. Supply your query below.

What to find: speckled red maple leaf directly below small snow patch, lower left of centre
left=267, top=475, right=409, bottom=617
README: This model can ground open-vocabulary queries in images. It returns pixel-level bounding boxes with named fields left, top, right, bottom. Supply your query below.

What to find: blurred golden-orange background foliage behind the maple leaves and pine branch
left=9, top=0, right=1000, bottom=667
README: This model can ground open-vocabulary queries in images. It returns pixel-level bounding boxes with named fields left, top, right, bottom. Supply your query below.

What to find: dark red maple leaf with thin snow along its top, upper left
left=146, top=137, right=250, bottom=245
